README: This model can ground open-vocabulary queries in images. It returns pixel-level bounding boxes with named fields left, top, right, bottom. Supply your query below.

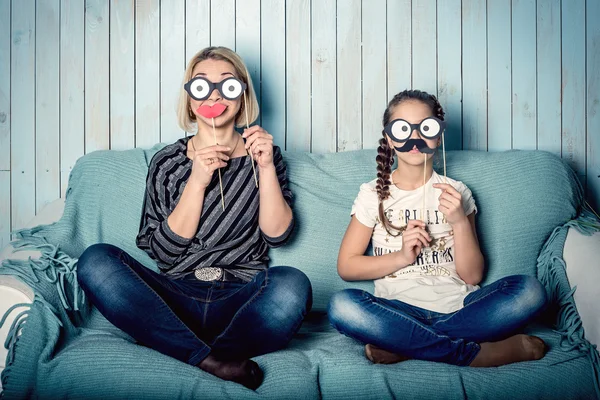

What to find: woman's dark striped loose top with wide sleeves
left=136, top=138, right=294, bottom=281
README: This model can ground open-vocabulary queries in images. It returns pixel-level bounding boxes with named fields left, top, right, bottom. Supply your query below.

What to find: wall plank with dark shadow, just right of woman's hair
left=260, top=0, right=286, bottom=149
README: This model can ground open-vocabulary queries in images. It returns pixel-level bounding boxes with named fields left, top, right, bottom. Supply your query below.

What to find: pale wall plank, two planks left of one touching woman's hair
left=110, top=0, right=135, bottom=150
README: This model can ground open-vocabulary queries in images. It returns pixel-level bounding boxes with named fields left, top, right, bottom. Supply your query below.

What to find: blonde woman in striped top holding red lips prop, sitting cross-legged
left=78, top=47, right=312, bottom=389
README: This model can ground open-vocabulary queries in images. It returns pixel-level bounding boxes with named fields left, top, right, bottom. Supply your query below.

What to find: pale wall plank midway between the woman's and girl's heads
left=311, top=0, right=337, bottom=153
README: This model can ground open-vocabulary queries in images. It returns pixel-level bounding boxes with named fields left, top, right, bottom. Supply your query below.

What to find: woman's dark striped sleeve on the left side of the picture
left=136, top=160, right=192, bottom=269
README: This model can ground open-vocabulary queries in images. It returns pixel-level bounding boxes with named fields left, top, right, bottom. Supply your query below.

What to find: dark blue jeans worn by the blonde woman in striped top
left=77, top=244, right=312, bottom=365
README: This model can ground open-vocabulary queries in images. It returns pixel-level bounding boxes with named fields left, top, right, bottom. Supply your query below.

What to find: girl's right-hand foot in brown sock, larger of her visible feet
left=470, top=334, right=547, bottom=367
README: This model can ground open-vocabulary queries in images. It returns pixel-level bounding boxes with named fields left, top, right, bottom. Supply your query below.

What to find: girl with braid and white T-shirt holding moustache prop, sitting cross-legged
left=328, top=90, right=546, bottom=367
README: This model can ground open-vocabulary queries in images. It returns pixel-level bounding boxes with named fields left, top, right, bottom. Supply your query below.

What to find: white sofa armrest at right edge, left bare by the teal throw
left=563, top=228, right=600, bottom=345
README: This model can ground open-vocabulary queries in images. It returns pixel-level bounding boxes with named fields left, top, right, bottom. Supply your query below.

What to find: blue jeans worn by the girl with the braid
left=328, top=275, right=546, bottom=365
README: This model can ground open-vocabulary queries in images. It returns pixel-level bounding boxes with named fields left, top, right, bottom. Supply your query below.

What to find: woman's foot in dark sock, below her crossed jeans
left=198, top=354, right=263, bottom=390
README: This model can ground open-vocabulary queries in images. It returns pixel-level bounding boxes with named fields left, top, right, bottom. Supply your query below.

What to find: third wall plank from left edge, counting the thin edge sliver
left=35, top=0, right=60, bottom=213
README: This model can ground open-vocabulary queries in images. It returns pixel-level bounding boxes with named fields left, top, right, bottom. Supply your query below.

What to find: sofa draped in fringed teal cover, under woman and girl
left=0, top=145, right=600, bottom=399
